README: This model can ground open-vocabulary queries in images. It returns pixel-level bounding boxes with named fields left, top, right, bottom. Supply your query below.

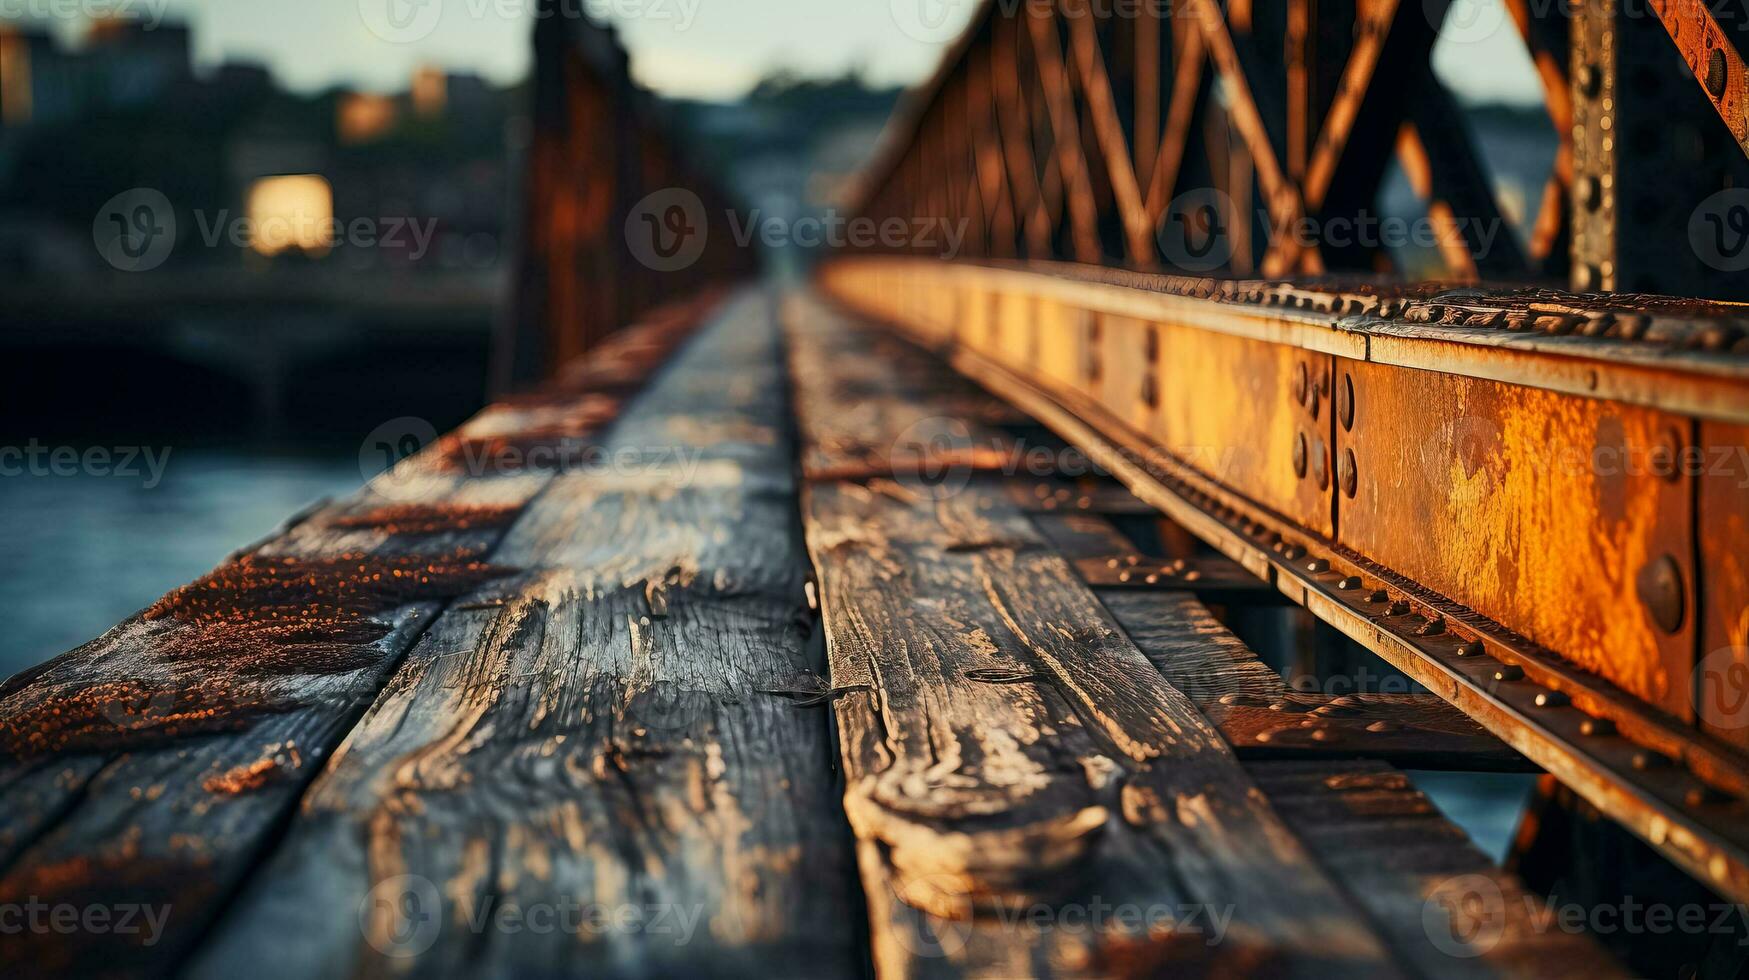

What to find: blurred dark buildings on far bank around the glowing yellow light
left=0, top=21, right=525, bottom=277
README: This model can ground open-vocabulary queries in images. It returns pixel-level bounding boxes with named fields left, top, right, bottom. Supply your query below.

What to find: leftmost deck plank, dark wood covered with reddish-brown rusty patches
left=0, top=299, right=717, bottom=975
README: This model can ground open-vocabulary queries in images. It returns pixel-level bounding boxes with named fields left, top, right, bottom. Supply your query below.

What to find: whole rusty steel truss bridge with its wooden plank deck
left=0, top=0, right=1749, bottom=978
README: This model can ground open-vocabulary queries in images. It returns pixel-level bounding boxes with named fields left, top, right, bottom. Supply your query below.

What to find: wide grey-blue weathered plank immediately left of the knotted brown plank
left=192, top=290, right=864, bottom=977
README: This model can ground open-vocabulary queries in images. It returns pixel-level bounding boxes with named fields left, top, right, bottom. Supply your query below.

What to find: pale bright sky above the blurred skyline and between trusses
left=10, top=0, right=1541, bottom=103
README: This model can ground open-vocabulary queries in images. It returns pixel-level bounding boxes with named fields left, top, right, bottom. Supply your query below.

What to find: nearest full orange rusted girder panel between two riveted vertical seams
left=1336, top=361, right=1695, bottom=718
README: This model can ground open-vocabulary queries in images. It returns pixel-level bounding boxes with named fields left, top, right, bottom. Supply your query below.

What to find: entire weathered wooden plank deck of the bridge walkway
left=0, top=292, right=1616, bottom=977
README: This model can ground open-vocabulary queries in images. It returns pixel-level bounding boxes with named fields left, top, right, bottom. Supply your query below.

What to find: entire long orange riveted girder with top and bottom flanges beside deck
left=822, top=259, right=1749, bottom=901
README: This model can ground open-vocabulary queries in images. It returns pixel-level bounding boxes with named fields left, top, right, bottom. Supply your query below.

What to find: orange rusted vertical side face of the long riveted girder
left=824, top=259, right=1749, bottom=721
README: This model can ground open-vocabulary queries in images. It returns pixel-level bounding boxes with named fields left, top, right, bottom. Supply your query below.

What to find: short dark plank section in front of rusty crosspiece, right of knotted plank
left=1245, top=761, right=1623, bottom=978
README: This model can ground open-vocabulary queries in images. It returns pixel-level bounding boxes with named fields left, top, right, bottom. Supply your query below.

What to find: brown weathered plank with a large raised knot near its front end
left=791, top=294, right=1396, bottom=977
